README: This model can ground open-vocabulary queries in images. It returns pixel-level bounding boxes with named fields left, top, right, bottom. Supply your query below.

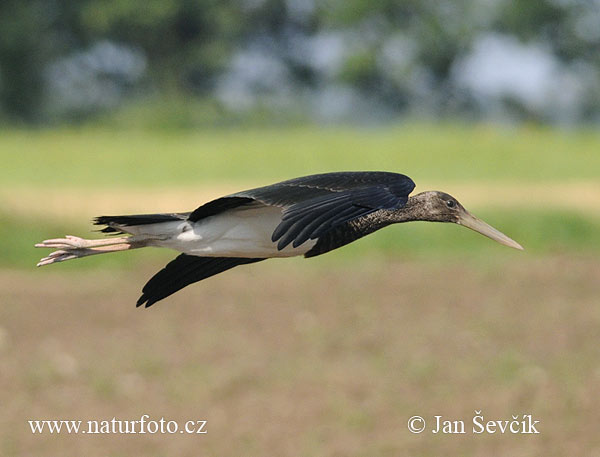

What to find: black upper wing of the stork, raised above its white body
left=189, top=171, right=415, bottom=250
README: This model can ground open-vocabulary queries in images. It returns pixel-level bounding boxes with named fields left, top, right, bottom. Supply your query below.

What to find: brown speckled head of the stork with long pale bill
left=407, top=191, right=523, bottom=250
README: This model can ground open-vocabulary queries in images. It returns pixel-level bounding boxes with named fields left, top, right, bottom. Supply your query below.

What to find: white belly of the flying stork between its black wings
left=155, top=206, right=316, bottom=258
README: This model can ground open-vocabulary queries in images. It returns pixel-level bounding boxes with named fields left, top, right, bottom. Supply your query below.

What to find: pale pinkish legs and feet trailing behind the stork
left=35, top=235, right=148, bottom=267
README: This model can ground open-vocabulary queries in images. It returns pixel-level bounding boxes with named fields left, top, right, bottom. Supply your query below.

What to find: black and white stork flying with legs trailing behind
left=35, top=171, right=523, bottom=308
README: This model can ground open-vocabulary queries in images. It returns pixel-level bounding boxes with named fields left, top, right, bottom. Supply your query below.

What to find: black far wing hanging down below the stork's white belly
left=136, top=254, right=265, bottom=308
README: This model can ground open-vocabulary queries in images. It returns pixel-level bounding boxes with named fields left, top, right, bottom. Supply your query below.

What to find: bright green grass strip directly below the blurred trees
left=0, top=125, right=600, bottom=187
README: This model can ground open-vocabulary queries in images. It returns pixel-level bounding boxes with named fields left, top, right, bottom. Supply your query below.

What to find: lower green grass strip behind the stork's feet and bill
left=0, top=210, right=600, bottom=270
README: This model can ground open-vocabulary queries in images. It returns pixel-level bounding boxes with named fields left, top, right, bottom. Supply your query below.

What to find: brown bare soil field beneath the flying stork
left=0, top=256, right=600, bottom=457
